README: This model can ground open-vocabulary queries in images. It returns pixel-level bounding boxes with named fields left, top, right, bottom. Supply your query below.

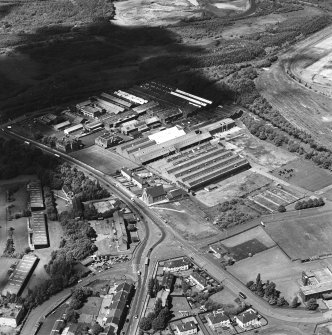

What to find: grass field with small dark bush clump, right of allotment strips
left=272, top=159, right=332, bottom=191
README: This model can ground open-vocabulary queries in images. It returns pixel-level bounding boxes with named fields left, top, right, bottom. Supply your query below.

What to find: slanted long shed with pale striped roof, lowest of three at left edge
left=1, top=255, right=38, bottom=296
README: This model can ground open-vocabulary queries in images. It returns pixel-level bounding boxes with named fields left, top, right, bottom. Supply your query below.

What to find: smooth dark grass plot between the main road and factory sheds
left=71, top=145, right=138, bottom=174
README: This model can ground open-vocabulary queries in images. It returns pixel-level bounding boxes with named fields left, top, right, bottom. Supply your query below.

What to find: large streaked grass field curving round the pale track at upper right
left=256, top=26, right=332, bottom=148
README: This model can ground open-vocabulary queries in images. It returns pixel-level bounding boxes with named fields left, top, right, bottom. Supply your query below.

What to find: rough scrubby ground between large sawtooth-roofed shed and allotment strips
left=196, top=170, right=271, bottom=207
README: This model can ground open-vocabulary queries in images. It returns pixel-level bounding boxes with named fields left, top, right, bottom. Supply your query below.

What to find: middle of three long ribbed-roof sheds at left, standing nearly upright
left=28, top=212, right=49, bottom=250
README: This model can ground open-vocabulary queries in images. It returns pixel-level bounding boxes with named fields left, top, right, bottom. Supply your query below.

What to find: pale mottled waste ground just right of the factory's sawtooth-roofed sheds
left=226, top=131, right=296, bottom=169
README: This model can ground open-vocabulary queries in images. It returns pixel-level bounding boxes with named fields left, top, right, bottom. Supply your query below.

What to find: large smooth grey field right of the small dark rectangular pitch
left=266, top=209, right=332, bottom=260
